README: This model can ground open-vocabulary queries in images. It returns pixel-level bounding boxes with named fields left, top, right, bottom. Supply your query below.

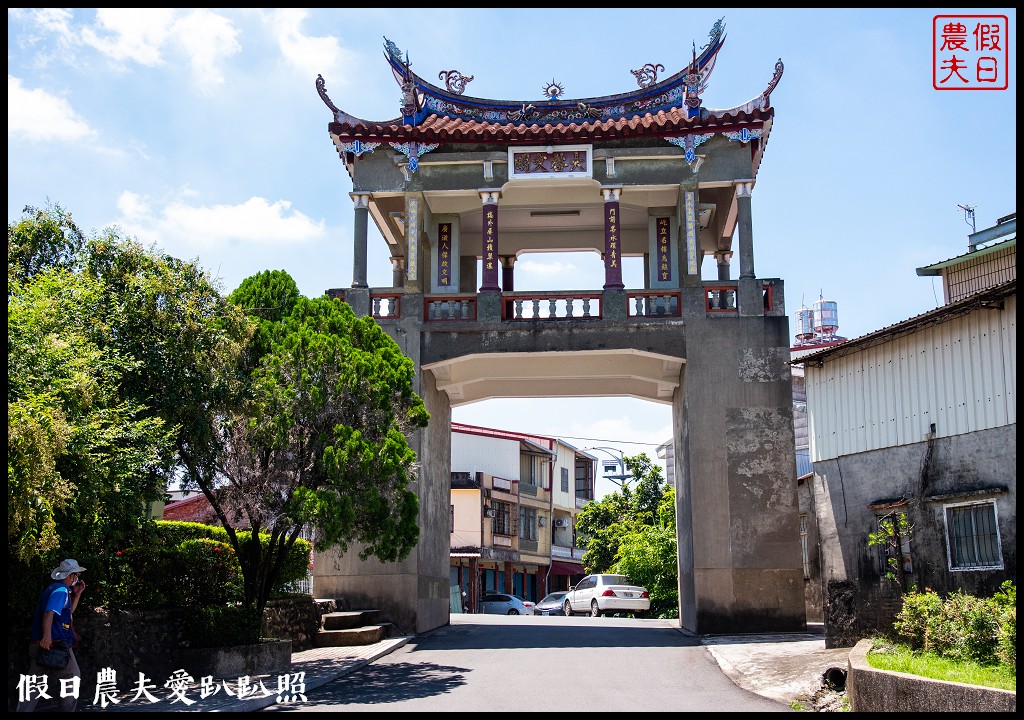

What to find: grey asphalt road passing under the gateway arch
left=262, top=615, right=793, bottom=712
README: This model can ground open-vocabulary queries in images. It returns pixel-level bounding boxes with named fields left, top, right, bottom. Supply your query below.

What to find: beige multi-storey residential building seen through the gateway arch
left=450, top=423, right=594, bottom=612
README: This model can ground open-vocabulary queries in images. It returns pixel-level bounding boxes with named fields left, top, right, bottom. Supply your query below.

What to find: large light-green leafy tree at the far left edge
left=7, top=208, right=211, bottom=607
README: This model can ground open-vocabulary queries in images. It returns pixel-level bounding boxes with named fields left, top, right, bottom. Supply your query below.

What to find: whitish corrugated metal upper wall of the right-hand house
left=805, top=295, right=1017, bottom=462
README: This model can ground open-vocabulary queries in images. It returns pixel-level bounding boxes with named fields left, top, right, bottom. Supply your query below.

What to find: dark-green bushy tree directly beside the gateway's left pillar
left=197, top=273, right=428, bottom=609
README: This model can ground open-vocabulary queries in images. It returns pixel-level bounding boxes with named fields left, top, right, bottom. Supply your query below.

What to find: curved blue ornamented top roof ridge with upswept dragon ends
left=384, top=18, right=725, bottom=125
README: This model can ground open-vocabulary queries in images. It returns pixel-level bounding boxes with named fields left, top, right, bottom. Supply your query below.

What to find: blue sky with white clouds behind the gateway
left=7, top=8, right=1017, bottom=497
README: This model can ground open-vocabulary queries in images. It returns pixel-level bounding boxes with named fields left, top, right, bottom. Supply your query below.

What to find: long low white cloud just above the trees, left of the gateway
left=115, top=192, right=326, bottom=253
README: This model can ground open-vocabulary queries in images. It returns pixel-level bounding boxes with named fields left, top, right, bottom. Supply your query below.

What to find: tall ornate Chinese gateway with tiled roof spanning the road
left=316, top=20, right=806, bottom=634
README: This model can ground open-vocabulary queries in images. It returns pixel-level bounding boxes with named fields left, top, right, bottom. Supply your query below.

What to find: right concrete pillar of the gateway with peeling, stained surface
left=674, top=316, right=806, bottom=634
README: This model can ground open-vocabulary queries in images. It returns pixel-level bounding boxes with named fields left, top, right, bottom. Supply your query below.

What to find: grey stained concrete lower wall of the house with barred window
left=812, top=425, right=1017, bottom=647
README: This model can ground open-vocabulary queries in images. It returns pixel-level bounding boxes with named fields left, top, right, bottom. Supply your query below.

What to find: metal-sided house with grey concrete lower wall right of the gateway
left=793, top=213, right=1017, bottom=647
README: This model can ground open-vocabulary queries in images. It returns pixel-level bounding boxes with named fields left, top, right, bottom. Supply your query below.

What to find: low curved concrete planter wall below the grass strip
left=846, top=640, right=1017, bottom=713
